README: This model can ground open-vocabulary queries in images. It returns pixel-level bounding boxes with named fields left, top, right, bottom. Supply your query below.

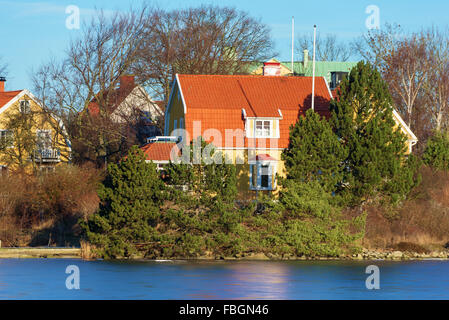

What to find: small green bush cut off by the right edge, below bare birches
left=422, top=131, right=449, bottom=170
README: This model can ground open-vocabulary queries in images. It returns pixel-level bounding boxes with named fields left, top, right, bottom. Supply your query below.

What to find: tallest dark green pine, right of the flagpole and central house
left=330, top=61, right=409, bottom=202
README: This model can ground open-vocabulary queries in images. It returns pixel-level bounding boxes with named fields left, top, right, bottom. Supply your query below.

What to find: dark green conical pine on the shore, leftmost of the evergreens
left=82, top=146, right=164, bottom=258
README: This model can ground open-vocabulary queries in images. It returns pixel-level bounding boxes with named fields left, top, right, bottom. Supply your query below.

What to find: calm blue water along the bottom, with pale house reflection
left=0, top=259, right=449, bottom=299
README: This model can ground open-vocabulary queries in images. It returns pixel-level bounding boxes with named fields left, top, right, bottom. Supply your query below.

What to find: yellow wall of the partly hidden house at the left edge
left=0, top=94, right=71, bottom=171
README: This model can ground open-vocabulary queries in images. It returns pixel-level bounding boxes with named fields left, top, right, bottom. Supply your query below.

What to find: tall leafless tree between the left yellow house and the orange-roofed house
left=33, top=7, right=151, bottom=165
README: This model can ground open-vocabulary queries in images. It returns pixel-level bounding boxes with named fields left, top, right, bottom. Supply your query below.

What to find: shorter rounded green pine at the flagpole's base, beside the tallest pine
left=282, top=109, right=347, bottom=192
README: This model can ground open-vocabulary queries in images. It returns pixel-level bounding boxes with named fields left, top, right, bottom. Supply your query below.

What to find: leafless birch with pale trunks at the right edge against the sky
left=353, top=24, right=449, bottom=151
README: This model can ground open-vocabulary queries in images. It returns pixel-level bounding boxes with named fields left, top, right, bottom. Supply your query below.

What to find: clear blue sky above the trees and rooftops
left=0, top=0, right=449, bottom=90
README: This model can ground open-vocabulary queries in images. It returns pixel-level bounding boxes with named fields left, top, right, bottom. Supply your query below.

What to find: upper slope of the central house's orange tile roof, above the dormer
left=178, top=75, right=331, bottom=118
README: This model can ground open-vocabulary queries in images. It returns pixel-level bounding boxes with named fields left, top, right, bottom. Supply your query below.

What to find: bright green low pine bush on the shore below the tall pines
left=280, top=180, right=366, bottom=256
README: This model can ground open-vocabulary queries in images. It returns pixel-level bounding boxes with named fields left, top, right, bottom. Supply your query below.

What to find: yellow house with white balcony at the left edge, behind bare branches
left=0, top=77, right=71, bottom=174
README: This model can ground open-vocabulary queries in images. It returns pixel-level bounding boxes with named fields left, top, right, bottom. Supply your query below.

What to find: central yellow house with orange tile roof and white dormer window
left=146, top=74, right=417, bottom=198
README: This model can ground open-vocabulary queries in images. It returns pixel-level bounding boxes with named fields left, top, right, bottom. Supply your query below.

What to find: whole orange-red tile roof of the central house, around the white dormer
left=178, top=75, right=331, bottom=148
